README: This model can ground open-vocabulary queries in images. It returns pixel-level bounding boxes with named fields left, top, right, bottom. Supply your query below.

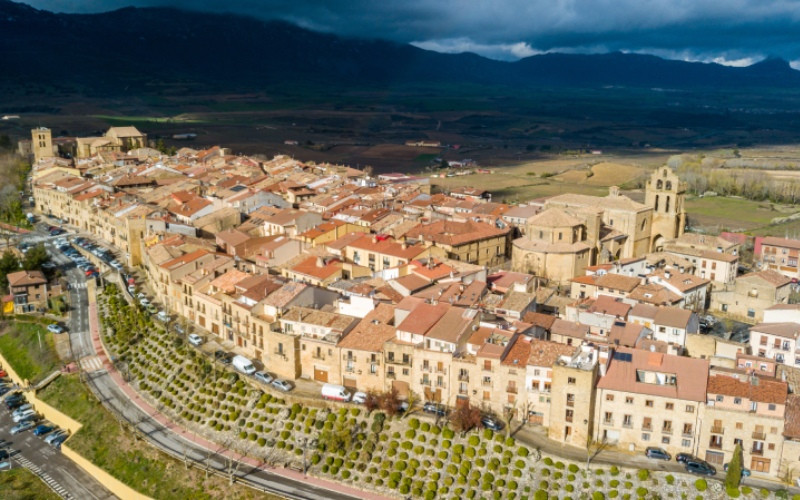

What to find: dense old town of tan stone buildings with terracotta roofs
left=20, top=127, right=800, bottom=488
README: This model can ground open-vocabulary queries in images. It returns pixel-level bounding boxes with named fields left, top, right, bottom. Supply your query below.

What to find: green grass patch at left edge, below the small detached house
left=0, top=322, right=61, bottom=383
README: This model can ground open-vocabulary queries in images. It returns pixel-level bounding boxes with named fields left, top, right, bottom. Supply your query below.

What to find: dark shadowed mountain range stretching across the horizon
left=0, top=0, right=800, bottom=92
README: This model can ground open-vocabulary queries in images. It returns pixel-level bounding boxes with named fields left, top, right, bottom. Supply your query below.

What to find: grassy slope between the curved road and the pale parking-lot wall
left=39, top=375, right=277, bottom=500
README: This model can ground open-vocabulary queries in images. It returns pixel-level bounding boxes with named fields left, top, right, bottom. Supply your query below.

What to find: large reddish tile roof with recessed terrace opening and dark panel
left=597, top=347, right=709, bottom=402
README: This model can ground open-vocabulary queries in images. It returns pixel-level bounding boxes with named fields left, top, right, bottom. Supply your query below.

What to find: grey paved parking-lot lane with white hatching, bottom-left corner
left=0, top=407, right=116, bottom=500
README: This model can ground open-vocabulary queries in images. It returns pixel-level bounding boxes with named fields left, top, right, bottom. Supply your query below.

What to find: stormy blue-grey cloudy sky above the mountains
left=17, top=0, right=800, bottom=69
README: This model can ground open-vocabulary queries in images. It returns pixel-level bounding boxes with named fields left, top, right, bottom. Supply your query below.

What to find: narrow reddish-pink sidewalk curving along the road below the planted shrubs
left=89, top=285, right=388, bottom=500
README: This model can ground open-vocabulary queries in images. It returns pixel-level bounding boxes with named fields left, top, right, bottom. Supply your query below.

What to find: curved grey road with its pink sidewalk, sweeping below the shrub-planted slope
left=35, top=228, right=376, bottom=500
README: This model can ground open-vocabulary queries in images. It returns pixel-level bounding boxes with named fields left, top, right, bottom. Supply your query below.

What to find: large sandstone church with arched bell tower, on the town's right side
left=511, top=167, right=686, bottom=283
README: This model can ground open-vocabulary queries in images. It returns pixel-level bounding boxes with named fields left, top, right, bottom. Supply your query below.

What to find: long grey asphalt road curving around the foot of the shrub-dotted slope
left=30, top=228, right=366, bottom=500
